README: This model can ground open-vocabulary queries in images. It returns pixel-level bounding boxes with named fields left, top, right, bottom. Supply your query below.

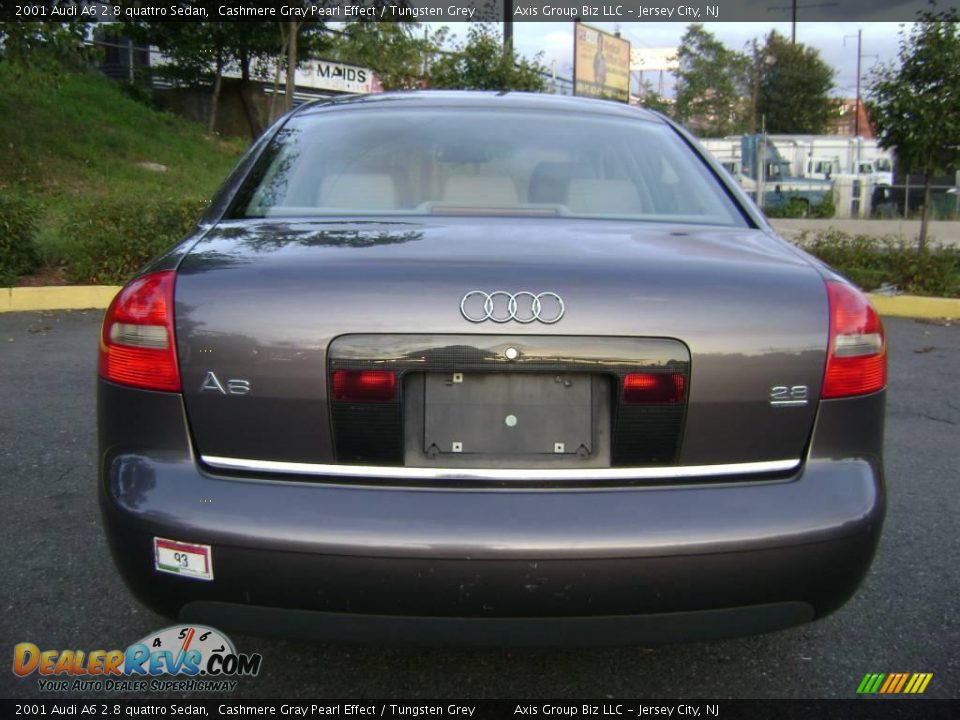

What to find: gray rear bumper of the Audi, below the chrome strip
left=100, top=380, right=884, bottom=645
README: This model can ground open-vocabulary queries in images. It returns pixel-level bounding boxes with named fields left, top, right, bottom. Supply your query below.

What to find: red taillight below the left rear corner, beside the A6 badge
left=100, top=270, right=180, bottom=392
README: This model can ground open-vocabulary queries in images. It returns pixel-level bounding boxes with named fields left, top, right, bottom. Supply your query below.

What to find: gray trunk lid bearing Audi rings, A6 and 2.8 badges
left=176, top=218, right=828, bottom=478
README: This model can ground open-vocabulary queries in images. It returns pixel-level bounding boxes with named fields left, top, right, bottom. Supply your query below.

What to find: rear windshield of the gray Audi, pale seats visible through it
left=229, top=108, right=745, bottom=226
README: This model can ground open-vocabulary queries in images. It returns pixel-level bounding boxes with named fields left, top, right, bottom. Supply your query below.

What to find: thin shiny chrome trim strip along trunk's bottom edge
left=201, top=455, right=800, bottom=480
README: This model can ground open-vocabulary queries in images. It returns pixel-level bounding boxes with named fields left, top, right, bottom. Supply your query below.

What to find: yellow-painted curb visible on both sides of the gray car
left=0, top=285, right=960, bottom=320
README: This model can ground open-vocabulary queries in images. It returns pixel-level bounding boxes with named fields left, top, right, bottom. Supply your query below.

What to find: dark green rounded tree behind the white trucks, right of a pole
left=754, top=31, right=834, bottom=135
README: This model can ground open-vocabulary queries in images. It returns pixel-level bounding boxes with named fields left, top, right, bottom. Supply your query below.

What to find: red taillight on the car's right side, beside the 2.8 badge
left=822, top=280, right=887, bottom=398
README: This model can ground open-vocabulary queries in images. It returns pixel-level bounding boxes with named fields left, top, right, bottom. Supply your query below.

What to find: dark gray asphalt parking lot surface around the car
left=0, top=311, right=960, bottom=699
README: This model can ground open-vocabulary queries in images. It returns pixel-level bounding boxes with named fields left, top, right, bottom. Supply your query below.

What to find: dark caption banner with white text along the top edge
left=0, top=0, right=960, bottom=23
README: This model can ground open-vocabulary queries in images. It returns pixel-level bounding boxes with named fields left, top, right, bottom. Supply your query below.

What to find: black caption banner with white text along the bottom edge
left=0, top=698, right=960, bottom=720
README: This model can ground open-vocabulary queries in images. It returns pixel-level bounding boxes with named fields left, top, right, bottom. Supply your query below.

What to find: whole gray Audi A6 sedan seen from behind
left=98, top=92, right=886, bottom=645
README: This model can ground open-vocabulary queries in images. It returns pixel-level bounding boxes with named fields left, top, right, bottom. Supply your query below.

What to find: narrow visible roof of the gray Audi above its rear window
left=293, top=90, right=664, bottom=122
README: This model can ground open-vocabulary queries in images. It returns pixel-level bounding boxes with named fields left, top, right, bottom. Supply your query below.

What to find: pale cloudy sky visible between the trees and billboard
left=426, top=19, right=903, bottom=98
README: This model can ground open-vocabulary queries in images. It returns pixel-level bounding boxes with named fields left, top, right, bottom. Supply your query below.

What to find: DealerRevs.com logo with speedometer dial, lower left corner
left=13, top=625, right=263, bottom=692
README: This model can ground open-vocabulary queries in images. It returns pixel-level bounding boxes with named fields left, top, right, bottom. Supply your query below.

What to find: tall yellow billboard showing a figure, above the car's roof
left=573, top=23, right=630, bottom=102
